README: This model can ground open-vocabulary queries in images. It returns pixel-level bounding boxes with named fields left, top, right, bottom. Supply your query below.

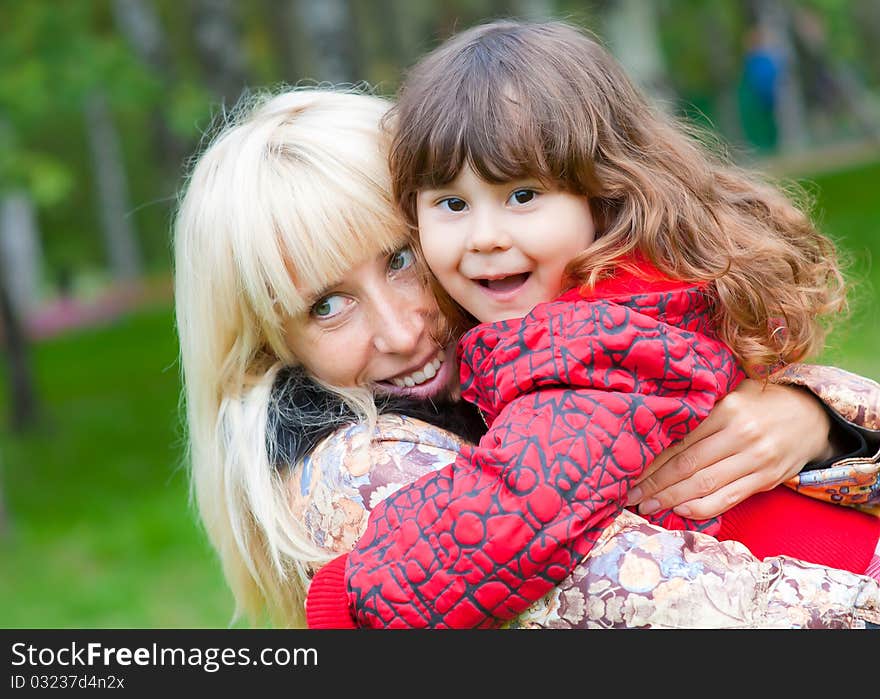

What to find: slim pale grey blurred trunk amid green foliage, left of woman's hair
left=85, top=91, right=141, bottom=281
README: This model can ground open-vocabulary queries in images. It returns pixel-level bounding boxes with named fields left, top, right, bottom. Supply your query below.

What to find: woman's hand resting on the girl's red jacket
left=627, top=379, right=833, bottom=519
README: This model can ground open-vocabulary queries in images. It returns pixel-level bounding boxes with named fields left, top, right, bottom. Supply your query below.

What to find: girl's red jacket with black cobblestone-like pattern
left=306, top=266, right=744, bottom=628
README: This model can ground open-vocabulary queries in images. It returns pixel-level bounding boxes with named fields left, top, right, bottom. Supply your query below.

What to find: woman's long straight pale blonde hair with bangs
left=174, top=89, right=406, bottom=626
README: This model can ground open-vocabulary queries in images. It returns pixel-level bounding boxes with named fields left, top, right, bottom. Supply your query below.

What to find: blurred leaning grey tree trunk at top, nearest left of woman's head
left=113, top=0, right=187, bottom=186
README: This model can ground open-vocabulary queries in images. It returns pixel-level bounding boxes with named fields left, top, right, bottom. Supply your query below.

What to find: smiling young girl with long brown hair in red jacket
left=308, top=17, right=880, bottom=626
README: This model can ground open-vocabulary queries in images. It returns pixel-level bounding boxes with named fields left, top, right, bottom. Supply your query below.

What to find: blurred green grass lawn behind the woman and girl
left=0, top=163, right=880, bottom=628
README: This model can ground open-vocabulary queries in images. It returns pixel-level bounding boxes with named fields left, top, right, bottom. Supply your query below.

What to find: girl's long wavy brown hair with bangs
left=387, top=21, right=846, bottom=376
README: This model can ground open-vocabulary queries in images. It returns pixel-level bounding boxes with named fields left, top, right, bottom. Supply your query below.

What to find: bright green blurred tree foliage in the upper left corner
left=0, top=2, right=167, bottom=277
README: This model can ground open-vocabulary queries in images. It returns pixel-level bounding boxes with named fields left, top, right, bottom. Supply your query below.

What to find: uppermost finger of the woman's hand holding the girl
left=627, top=432, right=742, bottom=507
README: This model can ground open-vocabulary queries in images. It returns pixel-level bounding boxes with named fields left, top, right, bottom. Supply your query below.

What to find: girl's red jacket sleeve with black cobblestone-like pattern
left=310, top=300, right=734, bottom=628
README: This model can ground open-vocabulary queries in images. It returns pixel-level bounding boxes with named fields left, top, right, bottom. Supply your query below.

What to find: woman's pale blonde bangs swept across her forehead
left=210, top=91, right=406, bottom=340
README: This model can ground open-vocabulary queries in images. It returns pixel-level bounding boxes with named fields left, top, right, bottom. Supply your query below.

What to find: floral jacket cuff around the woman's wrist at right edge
left=773, top=364, right=880, bottom=516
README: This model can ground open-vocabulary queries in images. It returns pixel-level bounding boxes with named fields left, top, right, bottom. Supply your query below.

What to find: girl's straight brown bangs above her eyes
left=398, top=28, right=595, bottom=189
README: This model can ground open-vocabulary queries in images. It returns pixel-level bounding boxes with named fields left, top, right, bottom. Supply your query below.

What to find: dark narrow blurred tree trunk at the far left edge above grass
left=0, top=195, right=37, bottom=432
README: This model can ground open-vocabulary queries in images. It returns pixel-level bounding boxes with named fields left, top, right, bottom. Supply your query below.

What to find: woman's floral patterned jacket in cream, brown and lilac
left=288, top=366, right=880, bottom=628
